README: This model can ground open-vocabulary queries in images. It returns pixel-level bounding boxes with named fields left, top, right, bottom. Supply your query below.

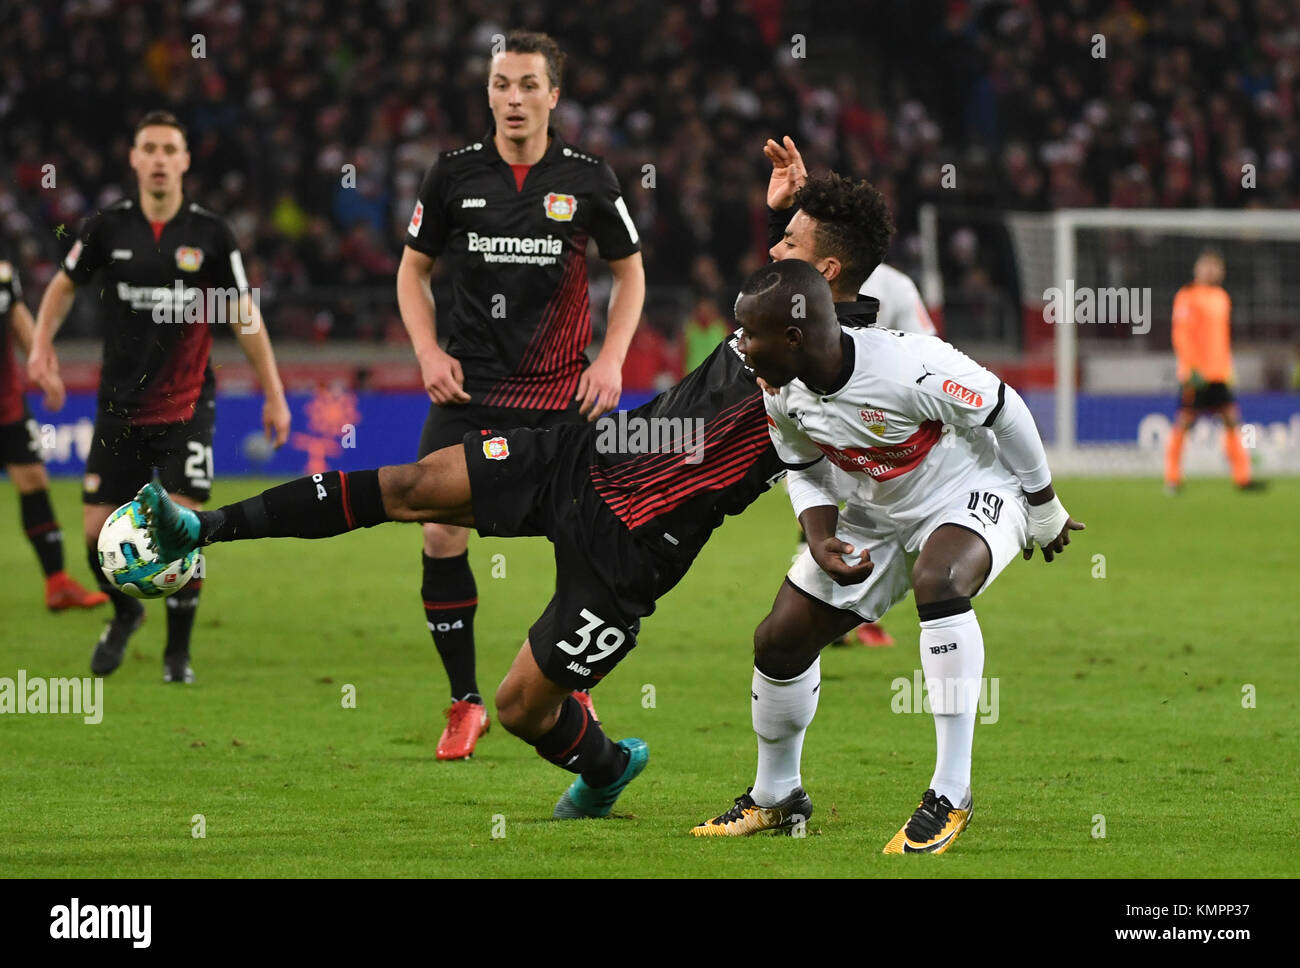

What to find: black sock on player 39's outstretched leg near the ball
left=198, top=470, right=389, bottom=544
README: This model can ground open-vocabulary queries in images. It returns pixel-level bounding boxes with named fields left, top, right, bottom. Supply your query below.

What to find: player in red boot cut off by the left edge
left=0, top=235, right=108, bottom=612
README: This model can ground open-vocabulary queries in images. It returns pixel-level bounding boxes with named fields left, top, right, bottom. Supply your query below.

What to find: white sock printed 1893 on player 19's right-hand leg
left=920, top=609, right=984, bottom=808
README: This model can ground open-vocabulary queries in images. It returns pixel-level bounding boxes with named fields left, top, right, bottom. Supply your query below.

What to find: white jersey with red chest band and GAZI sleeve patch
left=764, top=327, right=1019, bottom=521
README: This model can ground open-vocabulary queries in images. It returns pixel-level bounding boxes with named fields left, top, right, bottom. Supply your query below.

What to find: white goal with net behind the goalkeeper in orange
left=919, top=204, right=1300, bottom=476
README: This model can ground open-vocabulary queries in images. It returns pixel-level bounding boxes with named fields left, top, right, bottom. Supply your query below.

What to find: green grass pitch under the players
left=0, top=479, right=1300, bottom=877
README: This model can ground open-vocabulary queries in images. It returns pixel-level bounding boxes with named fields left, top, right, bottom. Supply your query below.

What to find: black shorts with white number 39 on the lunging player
left=464, top=425, right=690, bottom=689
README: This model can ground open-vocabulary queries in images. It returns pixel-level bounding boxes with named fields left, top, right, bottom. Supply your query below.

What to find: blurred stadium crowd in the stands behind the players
left=0, top=0, right=1300, bottom=356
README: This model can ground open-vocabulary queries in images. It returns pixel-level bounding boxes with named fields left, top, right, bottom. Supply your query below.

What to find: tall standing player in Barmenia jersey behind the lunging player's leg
left=398, top=31, right=645, bottom=760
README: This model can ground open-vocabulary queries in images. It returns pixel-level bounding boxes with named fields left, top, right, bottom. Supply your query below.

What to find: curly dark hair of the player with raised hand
left=794, top=172, right=894, bottom=291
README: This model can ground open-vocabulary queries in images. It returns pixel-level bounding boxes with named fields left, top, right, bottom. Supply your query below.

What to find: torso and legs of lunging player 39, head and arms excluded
left=139, top=307, right=785, bottom=819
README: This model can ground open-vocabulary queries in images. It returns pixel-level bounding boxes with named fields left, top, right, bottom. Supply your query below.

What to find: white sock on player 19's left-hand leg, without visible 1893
left=750, top=656, right=822, bottom=807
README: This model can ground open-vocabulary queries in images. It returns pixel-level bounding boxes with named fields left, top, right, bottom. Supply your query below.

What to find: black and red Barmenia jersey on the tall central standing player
left=406, top=123, right=641, bottom=409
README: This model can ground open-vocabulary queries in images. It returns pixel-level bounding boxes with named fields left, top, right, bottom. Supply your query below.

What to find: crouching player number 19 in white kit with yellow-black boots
left=693, top=260, right=1083, bottom=854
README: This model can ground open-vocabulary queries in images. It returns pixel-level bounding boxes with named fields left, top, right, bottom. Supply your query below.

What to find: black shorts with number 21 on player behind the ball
left=82, top=400, right=216, bottom=507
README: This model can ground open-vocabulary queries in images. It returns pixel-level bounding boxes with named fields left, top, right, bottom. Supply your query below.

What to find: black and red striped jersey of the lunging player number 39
left=590, top=335, right=787, bottom=559
